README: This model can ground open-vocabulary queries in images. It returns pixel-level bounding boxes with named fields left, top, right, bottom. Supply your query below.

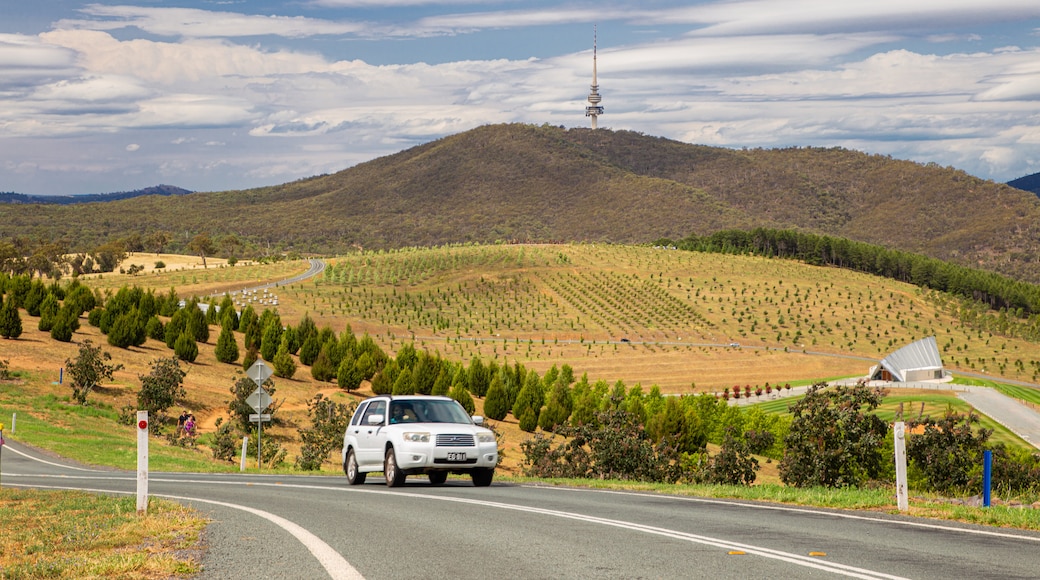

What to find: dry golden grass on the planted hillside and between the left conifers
left=8, top=244, right=1040, bottom=476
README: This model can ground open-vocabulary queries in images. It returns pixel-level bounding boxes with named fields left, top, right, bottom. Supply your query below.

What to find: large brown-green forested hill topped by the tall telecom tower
left=6, top=125, right=1040, bottom=282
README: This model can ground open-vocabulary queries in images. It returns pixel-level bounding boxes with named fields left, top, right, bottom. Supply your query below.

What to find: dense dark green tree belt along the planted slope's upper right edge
left=655, top=228, right=1040, bottom=318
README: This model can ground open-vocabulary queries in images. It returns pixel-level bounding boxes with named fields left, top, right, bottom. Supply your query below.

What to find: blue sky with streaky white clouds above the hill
left=6, top=0, right=1040, bottom=194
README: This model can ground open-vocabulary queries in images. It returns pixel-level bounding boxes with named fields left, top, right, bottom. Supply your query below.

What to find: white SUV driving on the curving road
left=343, top=395, right=498, bottom=487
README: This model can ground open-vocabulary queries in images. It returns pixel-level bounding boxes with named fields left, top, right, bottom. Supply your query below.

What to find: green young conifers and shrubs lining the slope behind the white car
left=0, top=276, right=1040, bottom=493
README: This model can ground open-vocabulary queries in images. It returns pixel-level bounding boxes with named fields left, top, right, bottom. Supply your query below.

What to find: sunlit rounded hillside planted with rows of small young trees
left=266, top=245, right=1040, bottom=384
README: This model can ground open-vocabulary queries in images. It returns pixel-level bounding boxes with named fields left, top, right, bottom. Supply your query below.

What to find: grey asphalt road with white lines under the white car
left=0, top=440, right=1040, bottom=580
